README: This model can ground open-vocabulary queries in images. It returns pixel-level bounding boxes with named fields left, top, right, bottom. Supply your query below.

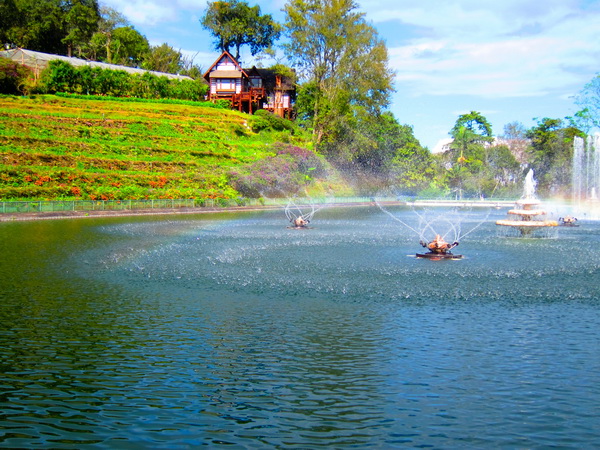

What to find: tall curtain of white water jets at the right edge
left=572, top=133, right=600, bottom=217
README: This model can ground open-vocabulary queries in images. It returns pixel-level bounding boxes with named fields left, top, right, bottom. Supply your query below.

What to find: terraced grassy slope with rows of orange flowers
left=0, top=96, right=310, bottom=200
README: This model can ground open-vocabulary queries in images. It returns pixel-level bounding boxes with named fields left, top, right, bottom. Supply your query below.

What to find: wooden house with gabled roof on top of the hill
left=204, top=51, right=295, bottom=119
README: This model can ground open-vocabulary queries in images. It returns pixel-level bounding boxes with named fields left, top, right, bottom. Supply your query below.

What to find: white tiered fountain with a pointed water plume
left=496, top=169, right=558, bottom=237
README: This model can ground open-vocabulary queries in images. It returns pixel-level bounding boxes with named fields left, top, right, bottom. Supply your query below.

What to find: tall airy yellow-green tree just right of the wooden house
left=283, top=0, right=393, bottom=149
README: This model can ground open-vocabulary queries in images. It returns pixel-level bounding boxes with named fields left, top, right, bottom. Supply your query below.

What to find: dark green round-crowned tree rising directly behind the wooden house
left=200, top=0, right=281, bottom=62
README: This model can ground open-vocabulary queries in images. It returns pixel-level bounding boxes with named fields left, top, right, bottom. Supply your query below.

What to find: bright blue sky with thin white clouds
left=101, top=0, right=600, bottom=151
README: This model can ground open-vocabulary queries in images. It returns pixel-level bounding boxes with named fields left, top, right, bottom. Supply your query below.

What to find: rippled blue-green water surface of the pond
left=0, top=207, right=600, bottom=448
